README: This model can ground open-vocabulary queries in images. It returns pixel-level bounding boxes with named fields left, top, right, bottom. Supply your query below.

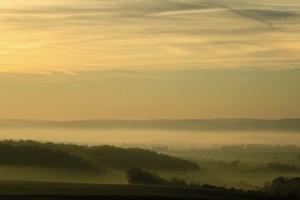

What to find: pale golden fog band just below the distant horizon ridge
left=0, top=129, right=300, bottom=148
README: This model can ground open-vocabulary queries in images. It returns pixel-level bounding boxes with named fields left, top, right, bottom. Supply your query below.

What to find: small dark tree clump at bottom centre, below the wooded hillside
left=126, top=168, right=188, bottom=186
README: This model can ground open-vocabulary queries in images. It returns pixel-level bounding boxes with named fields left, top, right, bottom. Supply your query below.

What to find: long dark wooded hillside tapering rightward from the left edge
left=0, top=140, right=199, bottom=172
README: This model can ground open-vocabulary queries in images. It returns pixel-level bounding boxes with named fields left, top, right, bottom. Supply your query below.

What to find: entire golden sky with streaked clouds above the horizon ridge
left=0, top=0, right=300, bottom=120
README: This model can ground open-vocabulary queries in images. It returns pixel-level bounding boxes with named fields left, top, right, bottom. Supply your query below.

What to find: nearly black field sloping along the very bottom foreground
left=0, top=181, right=273, bottom=200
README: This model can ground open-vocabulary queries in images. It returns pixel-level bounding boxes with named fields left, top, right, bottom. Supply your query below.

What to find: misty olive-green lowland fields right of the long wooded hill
left=167, top=144, right=300, bottom=190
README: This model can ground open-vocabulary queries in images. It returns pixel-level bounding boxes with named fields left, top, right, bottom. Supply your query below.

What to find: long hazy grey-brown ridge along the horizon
left=0, top=119, right=300, bottom=132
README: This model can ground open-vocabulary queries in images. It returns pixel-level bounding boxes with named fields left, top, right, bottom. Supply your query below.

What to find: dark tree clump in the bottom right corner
left=264, top=176, right=300, bottom=198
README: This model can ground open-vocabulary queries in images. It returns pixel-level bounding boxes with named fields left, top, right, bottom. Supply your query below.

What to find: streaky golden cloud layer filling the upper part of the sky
left=0, top=0, right=300, bottom=74
